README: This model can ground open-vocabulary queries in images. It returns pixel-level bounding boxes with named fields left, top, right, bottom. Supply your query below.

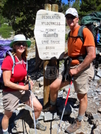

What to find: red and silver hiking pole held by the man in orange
left=57, top=80, right=72, bottom=134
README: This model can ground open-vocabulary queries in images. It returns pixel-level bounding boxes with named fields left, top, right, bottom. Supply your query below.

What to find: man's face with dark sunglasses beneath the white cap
left=66, top=14, right=79, bottom=29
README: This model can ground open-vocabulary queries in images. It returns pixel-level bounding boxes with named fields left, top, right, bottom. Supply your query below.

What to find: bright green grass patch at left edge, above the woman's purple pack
left=0, top=24, right=13, bottom=38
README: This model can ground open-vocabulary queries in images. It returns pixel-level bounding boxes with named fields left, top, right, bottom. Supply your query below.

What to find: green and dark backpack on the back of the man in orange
left=80, top=12, right=101, bottom=48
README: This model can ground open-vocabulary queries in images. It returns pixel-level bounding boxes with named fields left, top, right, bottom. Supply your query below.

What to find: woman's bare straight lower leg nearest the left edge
left=2, top=110, right=12, bottom=133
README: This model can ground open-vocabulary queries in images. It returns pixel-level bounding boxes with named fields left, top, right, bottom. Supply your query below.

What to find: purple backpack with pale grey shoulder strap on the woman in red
left=0, top=40, right=15, bottom=85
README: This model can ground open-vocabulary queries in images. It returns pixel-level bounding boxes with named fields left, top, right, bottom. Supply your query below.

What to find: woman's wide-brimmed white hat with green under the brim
left=10, top=34, right=31, bottom=47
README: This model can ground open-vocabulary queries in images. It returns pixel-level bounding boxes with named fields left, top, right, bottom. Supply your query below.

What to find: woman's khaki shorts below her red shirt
left=3, top=90, right=35, bottom=112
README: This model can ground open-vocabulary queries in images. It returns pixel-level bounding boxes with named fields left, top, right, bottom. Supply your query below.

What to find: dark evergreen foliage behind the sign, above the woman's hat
left=0, top=0, right=61, bottom=38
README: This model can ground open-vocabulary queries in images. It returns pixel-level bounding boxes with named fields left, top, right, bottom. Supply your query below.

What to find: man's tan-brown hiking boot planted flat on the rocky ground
left=65, top=119, right=81, bottom=134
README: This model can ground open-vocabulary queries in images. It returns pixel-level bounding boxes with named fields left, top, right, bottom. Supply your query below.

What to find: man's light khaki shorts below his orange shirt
left=58, top=63, right=94, bottom=94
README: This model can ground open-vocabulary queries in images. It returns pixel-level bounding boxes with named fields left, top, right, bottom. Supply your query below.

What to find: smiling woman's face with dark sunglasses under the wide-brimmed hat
left=14, top=42, right=27, bottom=54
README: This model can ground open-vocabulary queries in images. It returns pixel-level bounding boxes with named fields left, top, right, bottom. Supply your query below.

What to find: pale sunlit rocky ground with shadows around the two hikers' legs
left=0, top=43, right=101, bottom=134
